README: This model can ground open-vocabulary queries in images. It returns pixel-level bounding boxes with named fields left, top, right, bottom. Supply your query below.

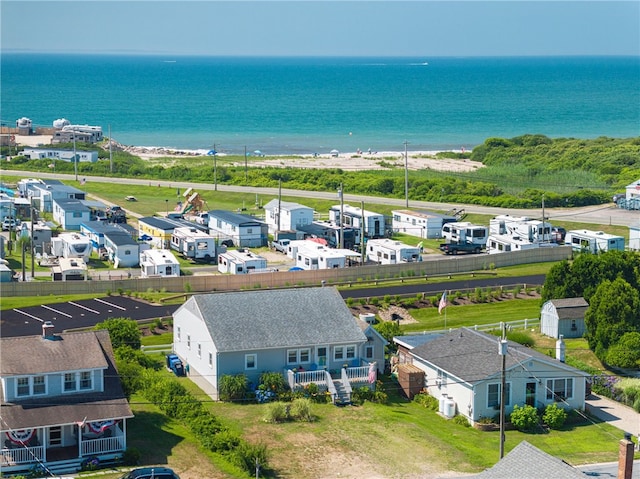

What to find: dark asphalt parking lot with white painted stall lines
left=0, top=296, right=179, bottom=338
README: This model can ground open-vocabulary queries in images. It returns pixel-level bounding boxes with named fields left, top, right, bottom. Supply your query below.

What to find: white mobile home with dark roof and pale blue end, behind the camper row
left=209, top=210, right=269, bottom=248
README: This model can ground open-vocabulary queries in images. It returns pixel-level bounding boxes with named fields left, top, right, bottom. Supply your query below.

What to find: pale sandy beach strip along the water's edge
left=15, top=135, right=483, bottom=172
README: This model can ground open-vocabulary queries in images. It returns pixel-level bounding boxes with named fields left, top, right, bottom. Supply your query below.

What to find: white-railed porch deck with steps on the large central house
left=285, top=363, right=377, bottom=404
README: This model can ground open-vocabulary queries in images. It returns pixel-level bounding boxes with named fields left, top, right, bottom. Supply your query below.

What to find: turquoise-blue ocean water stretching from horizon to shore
left=0, top=54, right=640, bottom=154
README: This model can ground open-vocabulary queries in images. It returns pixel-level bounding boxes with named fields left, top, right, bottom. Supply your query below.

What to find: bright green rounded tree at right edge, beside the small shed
left=584, top=278, right=640, bottom=361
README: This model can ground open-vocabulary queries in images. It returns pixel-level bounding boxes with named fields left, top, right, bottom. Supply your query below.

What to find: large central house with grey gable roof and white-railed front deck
left=173, top=286, right=384, bottom=402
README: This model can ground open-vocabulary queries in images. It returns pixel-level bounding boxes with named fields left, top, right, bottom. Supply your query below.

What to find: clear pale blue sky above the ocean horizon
left=0, top=0, right=640, bottom=58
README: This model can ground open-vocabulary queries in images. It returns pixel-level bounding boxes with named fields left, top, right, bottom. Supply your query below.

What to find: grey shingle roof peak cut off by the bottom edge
left=458, top=441, right=587, bottom=479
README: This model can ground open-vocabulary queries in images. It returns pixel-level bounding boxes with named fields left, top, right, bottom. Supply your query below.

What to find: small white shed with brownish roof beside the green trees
left=540, top=298, right=589, bottom=339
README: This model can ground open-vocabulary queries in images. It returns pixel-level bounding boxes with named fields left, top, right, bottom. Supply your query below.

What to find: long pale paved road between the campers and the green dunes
left=0, top=169, right=639, bottom=226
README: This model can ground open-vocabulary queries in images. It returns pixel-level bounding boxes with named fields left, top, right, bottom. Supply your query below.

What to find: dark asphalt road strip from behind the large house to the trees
left=340, top=274, right=545, bottom=299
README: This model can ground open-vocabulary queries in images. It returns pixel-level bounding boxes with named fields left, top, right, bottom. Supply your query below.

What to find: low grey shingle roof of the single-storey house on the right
left=411, top=328, right=581, bottom=384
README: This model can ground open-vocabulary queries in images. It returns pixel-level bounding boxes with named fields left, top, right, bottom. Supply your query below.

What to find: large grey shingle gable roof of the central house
left=181, top=287, right=366, bottom=351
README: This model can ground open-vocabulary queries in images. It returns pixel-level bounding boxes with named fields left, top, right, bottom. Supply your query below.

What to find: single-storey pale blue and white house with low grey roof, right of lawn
left=394, top=328, right=589, bottom=424
